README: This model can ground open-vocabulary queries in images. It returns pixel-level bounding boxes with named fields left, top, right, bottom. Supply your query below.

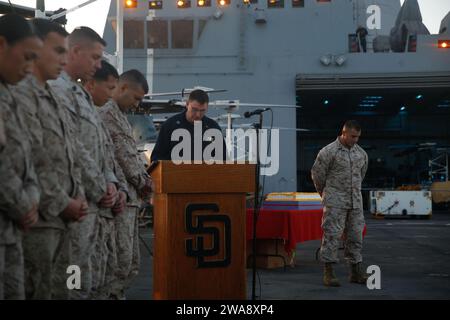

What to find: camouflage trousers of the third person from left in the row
left=69, top=213, right=99, bottom=300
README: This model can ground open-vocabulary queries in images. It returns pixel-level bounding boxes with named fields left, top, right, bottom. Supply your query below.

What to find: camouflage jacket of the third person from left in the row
left=49, top=71, right=118, bottom=208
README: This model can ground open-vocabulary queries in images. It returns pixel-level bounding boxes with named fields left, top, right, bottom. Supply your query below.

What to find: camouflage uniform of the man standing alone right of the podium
left=311, top=138, right=368, bottom=264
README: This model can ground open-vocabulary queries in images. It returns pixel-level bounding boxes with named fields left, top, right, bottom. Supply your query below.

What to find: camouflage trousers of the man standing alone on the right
left=320, top=207, right=364, bottom=264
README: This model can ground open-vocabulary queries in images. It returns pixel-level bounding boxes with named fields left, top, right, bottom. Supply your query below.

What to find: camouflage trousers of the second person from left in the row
left=23, top=228, right=69, bottom=300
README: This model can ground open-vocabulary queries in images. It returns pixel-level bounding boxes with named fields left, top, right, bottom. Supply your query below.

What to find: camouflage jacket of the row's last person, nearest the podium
left=100, top=100, right=150, bottom=205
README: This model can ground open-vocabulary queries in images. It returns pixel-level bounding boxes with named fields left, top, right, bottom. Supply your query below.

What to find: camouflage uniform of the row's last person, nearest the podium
left=100, top=100, right=150, bottom=294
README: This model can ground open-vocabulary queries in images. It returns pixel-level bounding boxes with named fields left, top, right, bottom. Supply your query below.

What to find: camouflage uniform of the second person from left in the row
left=14, top=76, right=101, bottom=299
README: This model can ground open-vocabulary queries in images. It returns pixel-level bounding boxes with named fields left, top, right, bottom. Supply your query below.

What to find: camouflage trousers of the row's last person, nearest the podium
left=113, top=207, right=140, bottom=295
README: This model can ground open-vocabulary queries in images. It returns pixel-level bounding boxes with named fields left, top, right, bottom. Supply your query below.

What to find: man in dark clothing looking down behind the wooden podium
left=151, top=89, right=226, bottom=164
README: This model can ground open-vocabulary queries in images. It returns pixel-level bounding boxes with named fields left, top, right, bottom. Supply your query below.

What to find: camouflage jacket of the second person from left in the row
left=13, top=76, right=96, bottom=228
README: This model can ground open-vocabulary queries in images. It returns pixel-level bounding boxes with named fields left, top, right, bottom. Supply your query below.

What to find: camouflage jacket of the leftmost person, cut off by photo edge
left=0, top=82, right=40, bottom=244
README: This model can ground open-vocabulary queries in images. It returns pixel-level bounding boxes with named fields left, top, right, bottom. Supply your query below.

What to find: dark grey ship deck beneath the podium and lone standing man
left=126, top=211, right=450, bottom=300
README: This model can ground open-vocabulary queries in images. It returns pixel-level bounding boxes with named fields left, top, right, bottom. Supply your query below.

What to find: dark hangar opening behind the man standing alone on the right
left=296, top=73, right=450, bottom=191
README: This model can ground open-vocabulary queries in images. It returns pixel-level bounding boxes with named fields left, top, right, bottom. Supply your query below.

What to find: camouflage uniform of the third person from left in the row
left=49, top=72, right=118, bottom=299
